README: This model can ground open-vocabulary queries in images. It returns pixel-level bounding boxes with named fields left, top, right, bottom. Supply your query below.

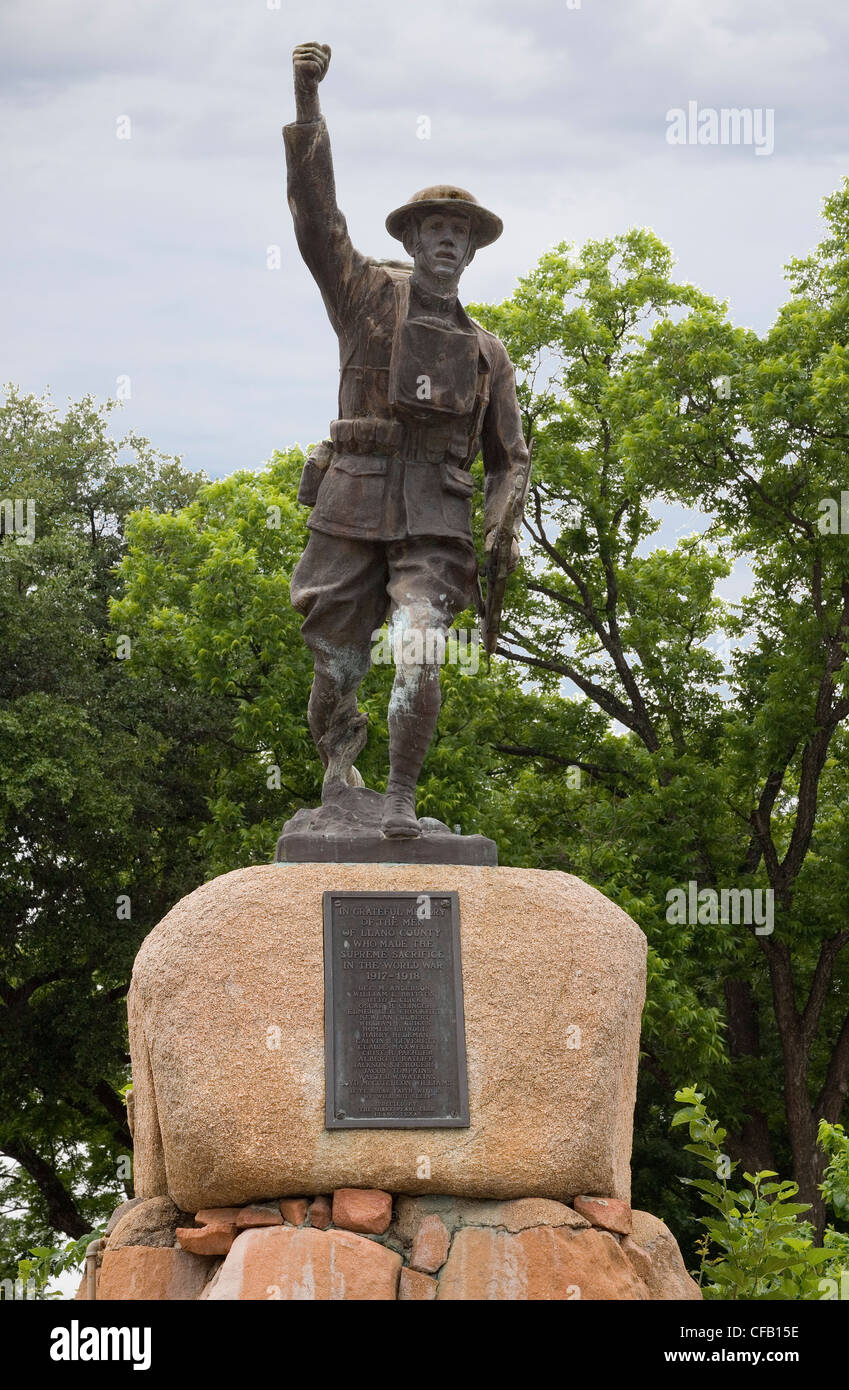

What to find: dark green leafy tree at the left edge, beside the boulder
left=0, top=388, right=206, bottom=1277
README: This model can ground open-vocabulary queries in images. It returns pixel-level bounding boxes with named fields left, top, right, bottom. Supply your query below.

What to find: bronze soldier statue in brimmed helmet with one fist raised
left=283, top=43, right=528, bottom=837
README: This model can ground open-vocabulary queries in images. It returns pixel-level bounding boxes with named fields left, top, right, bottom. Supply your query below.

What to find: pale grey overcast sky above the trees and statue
left=0, top=0, right=849, bottom=475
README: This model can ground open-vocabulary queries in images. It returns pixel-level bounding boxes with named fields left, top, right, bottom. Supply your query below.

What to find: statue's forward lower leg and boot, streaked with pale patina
left=381, top=666, right=439, bottom=840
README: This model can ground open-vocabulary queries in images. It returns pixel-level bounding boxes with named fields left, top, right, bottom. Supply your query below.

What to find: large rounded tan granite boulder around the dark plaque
left=128, top=863, right=646, bottom=1212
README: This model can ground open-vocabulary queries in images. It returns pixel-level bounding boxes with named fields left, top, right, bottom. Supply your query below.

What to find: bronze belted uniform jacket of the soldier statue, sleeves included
left=283, top=120, right=527, bottom=541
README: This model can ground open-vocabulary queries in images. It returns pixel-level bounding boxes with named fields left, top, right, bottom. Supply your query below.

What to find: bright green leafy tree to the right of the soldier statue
left=477, top=188, right=849, bottom=1226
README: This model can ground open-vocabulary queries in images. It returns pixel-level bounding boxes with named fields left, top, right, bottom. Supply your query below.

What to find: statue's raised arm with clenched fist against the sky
left=283, top=43, right=368, bottom=331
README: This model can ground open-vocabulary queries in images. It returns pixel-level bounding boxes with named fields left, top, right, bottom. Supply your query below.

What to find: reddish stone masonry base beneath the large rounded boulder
left=76, top=1187, right=702, bottom=1302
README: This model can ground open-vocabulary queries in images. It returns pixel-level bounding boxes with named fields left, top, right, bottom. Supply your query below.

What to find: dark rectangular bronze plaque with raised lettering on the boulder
left=324, top=892, right=468, bottom=1129
